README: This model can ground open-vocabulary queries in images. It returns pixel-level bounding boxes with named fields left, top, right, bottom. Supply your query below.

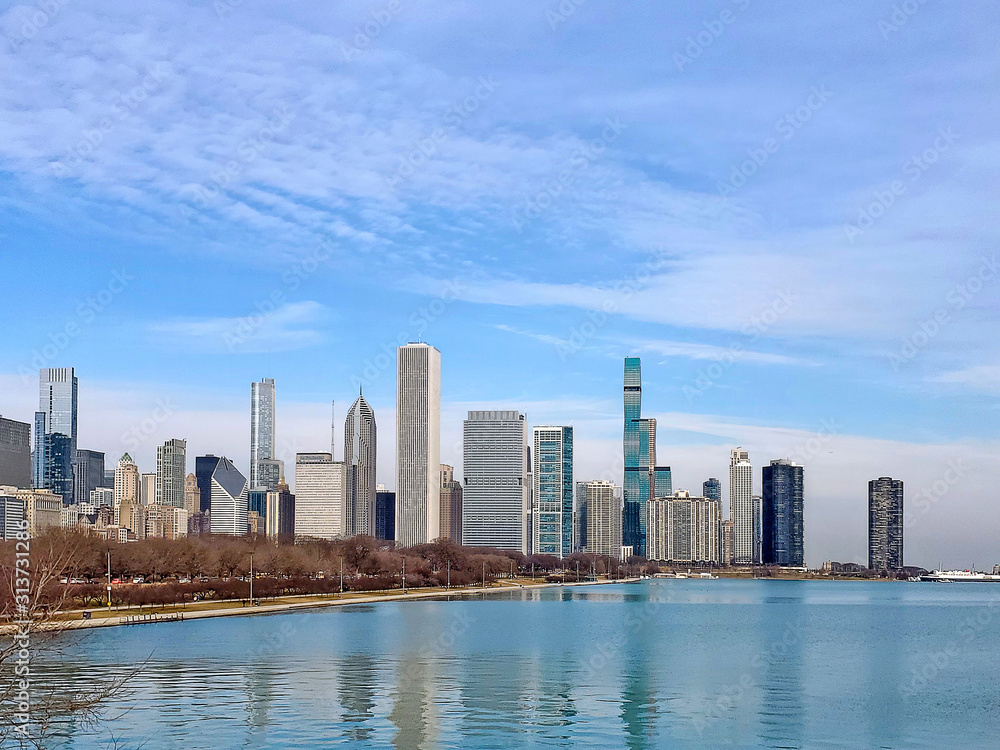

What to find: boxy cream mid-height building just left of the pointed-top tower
left=295, top=453, right=345, bottom=539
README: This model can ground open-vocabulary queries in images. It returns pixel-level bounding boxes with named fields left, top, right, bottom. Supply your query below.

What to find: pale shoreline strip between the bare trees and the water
left=25, top=578, right=643, bottom=635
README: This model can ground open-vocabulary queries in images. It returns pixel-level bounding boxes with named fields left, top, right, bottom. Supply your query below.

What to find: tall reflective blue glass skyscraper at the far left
left=34, top=367, right=77, bottom=505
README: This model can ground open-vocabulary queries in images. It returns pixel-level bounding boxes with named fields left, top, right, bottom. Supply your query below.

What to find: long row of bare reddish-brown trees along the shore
left=0, top=529, right=659, bottom=612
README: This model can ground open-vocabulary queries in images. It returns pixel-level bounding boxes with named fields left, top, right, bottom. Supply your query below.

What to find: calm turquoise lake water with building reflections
left=43, top=580, right=1000, bottom=750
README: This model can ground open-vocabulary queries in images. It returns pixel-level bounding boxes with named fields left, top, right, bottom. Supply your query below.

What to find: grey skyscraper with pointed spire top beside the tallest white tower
left=344, top=395, right=376, bottom=536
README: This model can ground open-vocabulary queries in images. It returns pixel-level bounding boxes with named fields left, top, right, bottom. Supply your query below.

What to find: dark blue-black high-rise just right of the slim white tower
left=760, top=459, right=805, bottom=567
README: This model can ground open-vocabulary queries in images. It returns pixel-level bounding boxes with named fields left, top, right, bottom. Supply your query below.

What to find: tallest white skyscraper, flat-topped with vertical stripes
left=396, top=343, right=441, bottom=547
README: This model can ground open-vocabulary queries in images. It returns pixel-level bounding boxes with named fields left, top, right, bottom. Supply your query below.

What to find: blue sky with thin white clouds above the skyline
left=0, top=0, right=1000, bottom=565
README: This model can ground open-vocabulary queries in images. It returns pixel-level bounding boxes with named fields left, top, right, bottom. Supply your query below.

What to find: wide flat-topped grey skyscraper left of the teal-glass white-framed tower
left=464, top=411, right=529, bottom=554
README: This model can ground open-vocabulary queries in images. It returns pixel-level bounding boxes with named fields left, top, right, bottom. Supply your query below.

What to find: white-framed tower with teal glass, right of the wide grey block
left=531, top=426, right=573, bottom=558
